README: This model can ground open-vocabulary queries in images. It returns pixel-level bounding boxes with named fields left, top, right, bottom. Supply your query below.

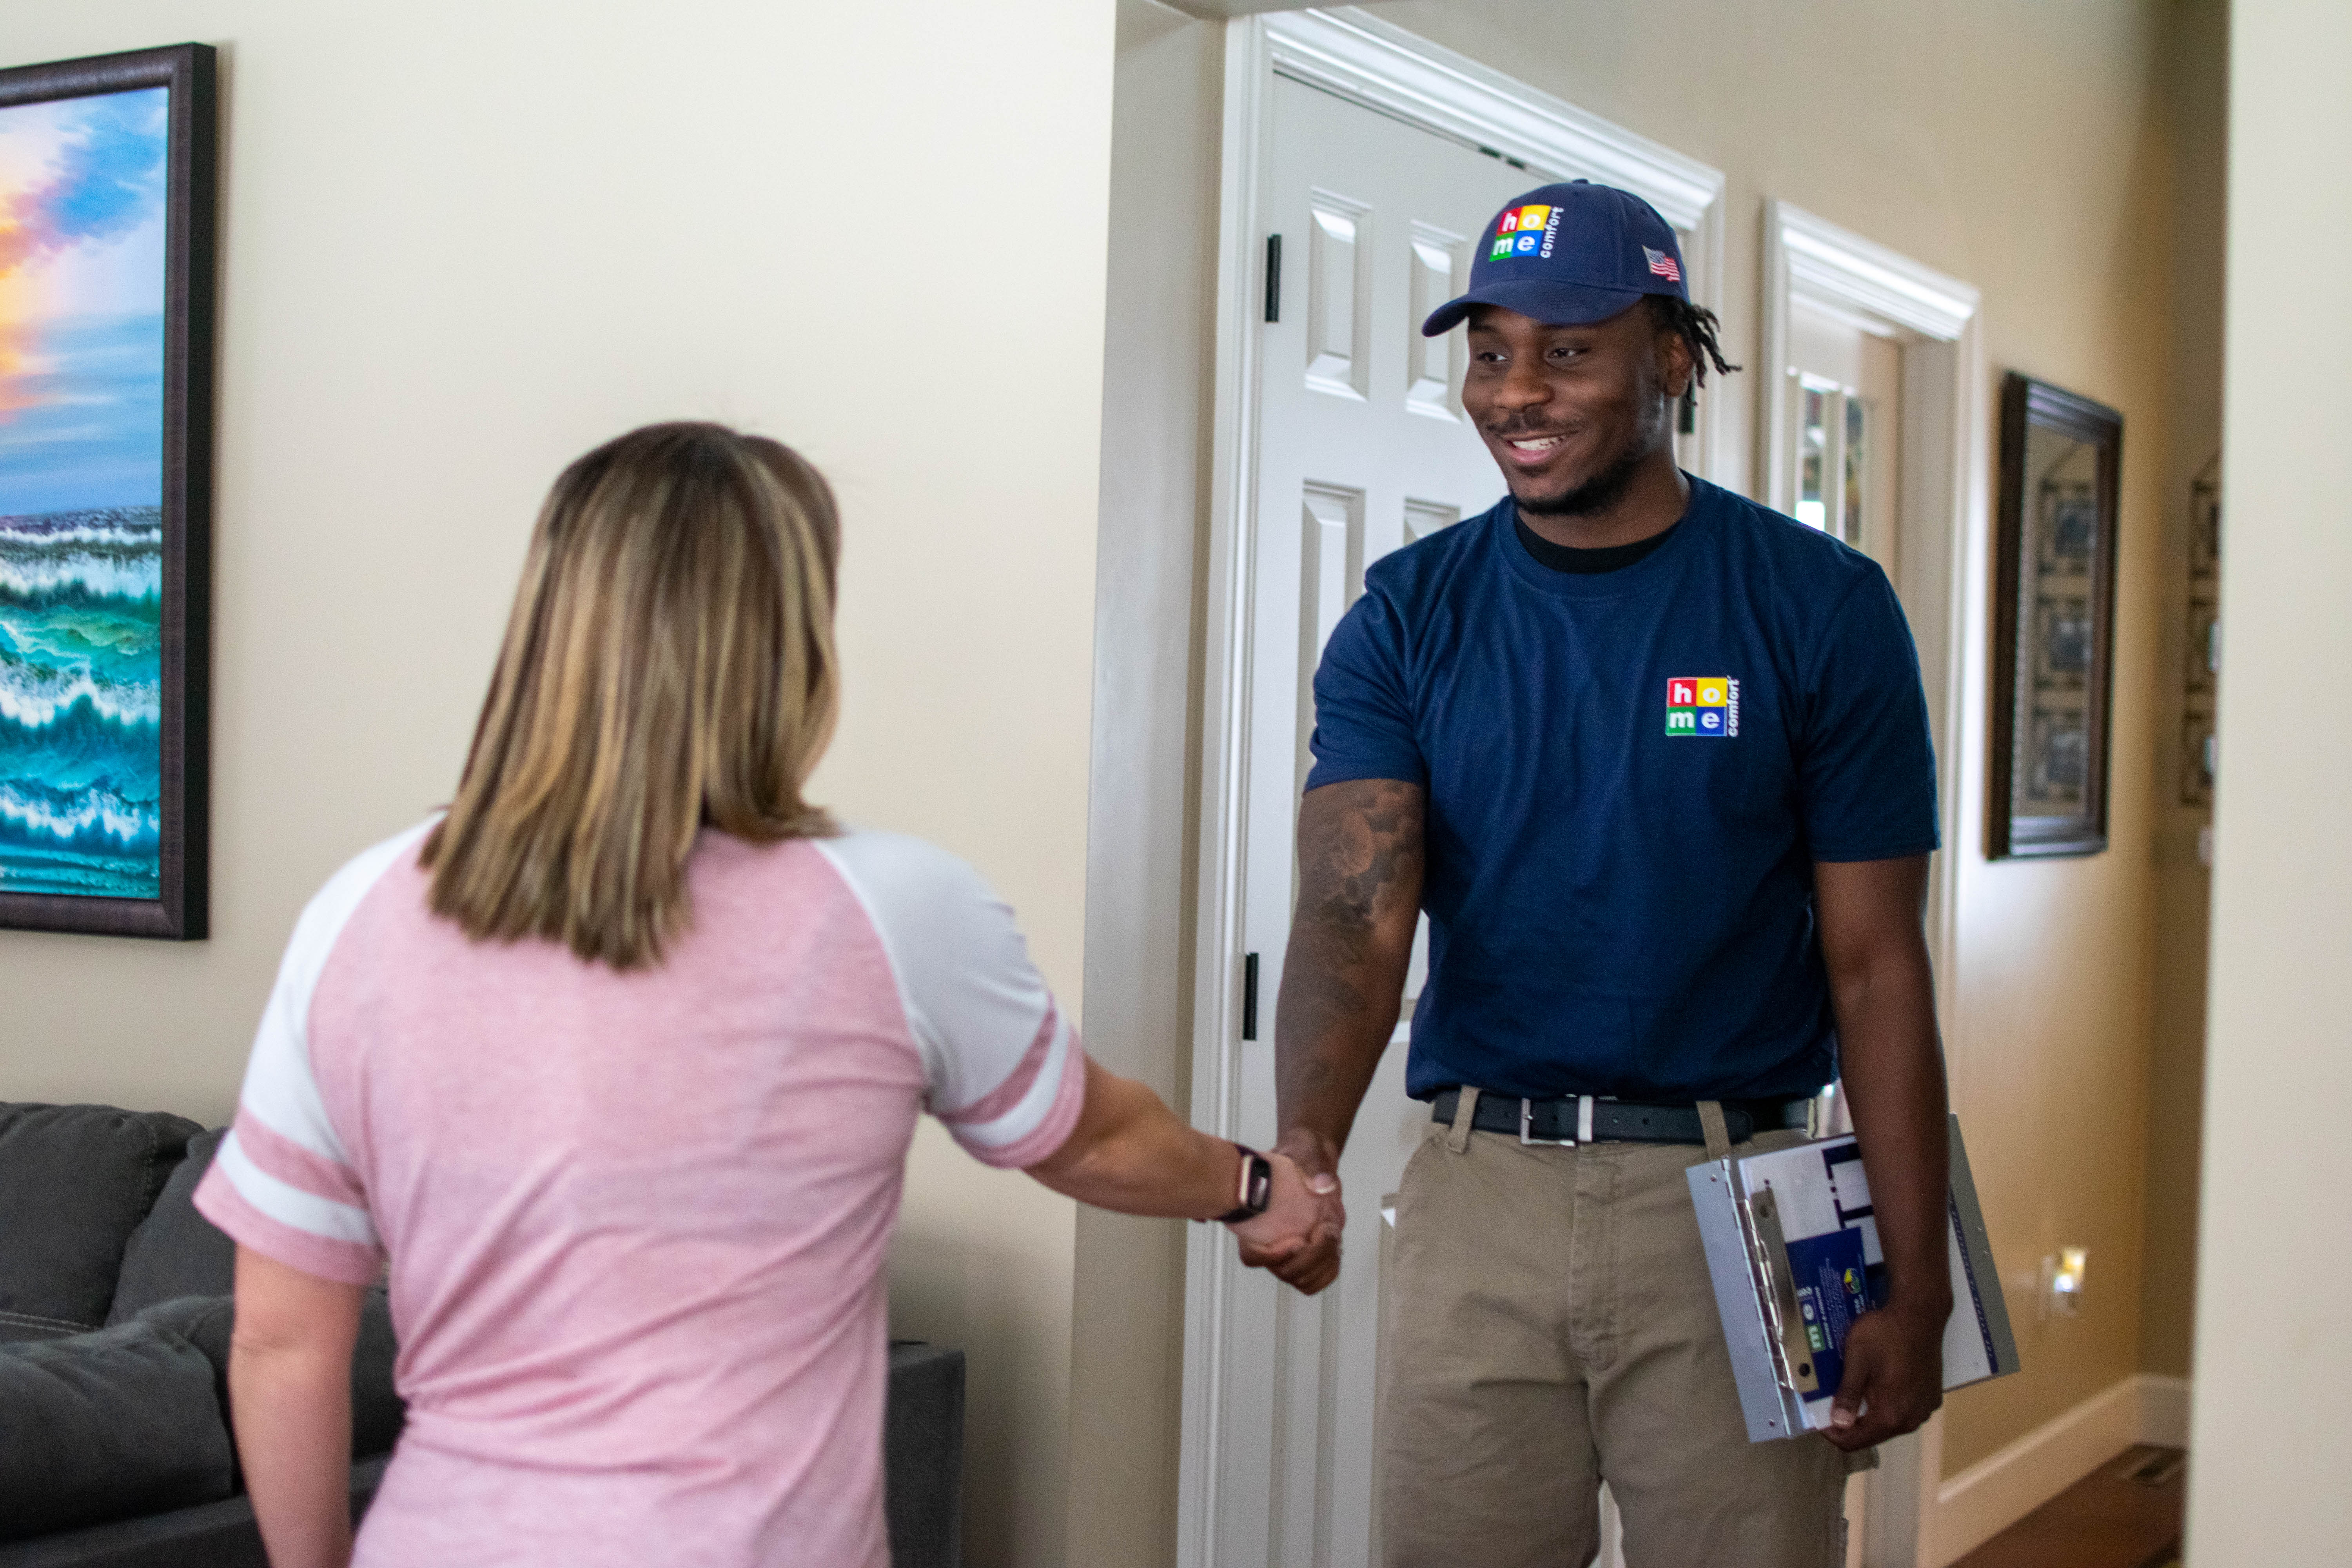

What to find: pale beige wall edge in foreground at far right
left=2187, top=0, right=2352, bottom=1568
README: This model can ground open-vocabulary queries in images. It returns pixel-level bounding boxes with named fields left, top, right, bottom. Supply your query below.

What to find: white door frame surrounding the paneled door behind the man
left=1195, top=7, right=1731, bottom=1568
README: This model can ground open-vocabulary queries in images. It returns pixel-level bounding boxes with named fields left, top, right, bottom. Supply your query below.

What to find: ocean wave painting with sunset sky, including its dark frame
left=0, top=45, right=216, bottom=940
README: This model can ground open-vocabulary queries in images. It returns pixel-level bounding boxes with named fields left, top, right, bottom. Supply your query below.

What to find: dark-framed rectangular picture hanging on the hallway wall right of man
left=1985, top=372, right=2124, bottom=860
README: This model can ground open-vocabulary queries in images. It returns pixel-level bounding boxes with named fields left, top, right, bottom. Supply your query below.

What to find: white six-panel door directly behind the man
left=1209, top=78, right=1571, bottom=1568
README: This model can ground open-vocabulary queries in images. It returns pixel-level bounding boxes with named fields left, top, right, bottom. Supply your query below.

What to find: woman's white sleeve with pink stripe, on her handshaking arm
left=814, top=832, right=1087, bottom=1166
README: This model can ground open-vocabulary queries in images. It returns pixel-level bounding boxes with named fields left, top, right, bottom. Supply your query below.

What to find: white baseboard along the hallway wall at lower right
left=1924, top=1373, right=2190, bottom=1568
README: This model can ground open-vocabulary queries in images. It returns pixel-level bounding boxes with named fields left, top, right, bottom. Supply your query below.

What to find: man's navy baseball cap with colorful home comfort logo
left=1421, top=179, right=1691, bottom=339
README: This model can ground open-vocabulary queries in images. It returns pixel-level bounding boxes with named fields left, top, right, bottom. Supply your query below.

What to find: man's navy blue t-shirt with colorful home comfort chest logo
left=1305, top=479, right=1938, bottom=1103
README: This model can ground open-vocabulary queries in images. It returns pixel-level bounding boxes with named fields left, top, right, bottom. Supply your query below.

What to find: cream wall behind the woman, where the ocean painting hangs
left=0, top=0, right=1112, bottom=1563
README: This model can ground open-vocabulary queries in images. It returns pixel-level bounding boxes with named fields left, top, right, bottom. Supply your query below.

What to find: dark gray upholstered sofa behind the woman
left=0, top=1103, right=964, bottom=1568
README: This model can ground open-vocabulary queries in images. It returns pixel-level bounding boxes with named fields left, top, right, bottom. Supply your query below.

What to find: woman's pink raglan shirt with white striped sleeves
left=195, top=828, right=1084, bottom=1568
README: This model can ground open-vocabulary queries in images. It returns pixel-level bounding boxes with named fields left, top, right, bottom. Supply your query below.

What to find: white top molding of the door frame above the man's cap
left=1258, top=5, right=1724, bottom=228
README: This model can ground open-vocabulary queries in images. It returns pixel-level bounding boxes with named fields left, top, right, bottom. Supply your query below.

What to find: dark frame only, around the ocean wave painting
left=0, top=45, right=219, bottom=940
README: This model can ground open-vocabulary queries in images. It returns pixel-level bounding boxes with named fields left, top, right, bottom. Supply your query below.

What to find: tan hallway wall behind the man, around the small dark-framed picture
left=1096, top=0, right=2218, bottom=1472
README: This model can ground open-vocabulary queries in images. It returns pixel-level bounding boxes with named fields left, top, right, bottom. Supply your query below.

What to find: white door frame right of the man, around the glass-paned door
left=1755, top=200, right=1987, bottom=1568
